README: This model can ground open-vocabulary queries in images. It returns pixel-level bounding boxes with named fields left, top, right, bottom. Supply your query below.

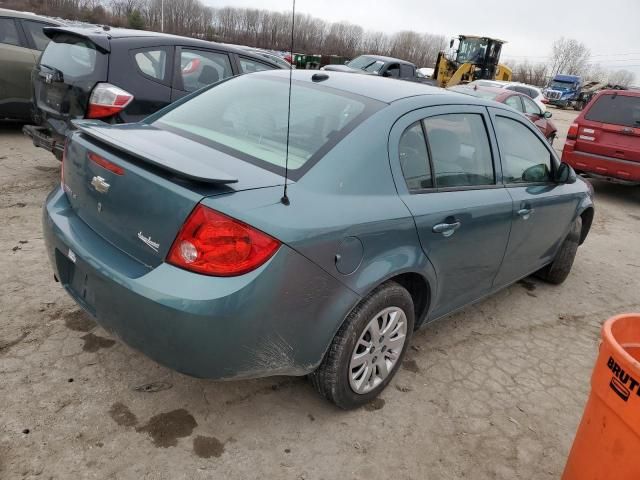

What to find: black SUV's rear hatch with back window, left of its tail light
left=33, top=30, right=109, bottom=137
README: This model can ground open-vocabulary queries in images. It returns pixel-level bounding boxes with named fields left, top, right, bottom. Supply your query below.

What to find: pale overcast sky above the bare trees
left=202, top=0, right=640, bottom=80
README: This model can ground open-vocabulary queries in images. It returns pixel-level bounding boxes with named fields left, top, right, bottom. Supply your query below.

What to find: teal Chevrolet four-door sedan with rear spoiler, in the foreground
left=43, top=71, right=594, bottom=408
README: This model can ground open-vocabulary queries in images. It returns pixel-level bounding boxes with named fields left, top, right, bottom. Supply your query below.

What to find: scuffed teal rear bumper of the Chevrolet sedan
left=43, top=188, right=359, bottom=379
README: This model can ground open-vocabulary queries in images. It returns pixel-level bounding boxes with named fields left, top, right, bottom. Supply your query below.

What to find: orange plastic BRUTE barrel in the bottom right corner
left=562, top=313, right=640, bottom=480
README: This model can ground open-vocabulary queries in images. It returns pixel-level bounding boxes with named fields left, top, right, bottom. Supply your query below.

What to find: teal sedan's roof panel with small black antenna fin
left=250, top=69, right=508, bottom=106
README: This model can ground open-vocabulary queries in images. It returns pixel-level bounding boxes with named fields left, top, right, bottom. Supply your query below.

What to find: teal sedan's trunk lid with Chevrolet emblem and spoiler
left=63, top=121, right=283, bottom=268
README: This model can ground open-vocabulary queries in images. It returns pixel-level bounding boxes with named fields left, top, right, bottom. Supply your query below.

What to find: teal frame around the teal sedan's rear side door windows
left=387, top=104, right=505, bottom=195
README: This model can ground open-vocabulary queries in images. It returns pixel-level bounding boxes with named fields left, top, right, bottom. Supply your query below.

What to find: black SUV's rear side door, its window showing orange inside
left=171, top=46, right=234, bottom=101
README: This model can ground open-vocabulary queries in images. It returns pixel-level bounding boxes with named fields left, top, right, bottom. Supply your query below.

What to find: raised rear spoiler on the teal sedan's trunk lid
left=71, top=120, right=238, bottom=184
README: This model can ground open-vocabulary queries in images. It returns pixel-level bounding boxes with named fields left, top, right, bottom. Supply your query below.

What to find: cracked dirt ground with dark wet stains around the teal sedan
left=0, top=109, right=640, bottom=480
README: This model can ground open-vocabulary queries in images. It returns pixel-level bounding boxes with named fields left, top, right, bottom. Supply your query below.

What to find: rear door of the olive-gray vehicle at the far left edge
left=0, top=17, right=36, bottom=119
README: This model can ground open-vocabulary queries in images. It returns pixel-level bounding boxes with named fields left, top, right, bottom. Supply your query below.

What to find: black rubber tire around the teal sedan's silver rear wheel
left=309, top=281, right=415, bottom=410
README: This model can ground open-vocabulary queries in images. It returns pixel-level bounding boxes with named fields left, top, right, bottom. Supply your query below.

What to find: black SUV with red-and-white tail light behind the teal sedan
left=24, top=26, right=281, bottom=159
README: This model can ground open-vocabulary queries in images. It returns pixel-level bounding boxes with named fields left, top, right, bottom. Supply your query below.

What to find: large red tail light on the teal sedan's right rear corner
left=167, top=205, right=280, bottom=277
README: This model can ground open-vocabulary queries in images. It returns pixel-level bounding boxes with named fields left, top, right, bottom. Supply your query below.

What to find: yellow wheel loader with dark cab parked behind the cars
left=433, top=35, right=512, bottom=88
